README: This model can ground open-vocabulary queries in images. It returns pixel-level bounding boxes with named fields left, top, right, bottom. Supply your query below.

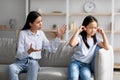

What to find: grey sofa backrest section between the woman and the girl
left=39, top=42, right=73, bottom=67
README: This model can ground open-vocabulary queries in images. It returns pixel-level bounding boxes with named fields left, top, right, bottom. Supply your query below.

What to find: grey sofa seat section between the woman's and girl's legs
left=38, top=67, right=68, bottom=80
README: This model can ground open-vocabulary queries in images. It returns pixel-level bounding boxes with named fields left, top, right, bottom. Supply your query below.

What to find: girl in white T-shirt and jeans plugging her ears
left=68, top=15, right=109, bottom=80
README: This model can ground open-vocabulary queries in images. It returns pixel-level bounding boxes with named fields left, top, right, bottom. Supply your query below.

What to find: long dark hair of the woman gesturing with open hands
left=22, top=11, right=41, bottom=30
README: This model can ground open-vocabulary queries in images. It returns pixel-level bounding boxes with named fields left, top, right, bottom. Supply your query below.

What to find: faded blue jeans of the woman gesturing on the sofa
left=8, top=58, right=39, bottom=80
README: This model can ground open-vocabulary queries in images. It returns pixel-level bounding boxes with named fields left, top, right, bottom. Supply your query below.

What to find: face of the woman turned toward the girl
left=30, top=16, right=42, bottom=30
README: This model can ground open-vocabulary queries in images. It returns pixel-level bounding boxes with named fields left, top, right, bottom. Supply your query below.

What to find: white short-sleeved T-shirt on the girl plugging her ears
left=72, top=35, right=100, bottom=63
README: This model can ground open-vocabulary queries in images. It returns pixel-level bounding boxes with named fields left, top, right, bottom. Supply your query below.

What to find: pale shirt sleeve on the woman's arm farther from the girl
left=16, top=31, right=28, bottom=58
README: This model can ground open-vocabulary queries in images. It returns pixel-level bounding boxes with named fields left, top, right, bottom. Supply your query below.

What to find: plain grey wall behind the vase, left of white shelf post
left=0, top=0, right=25, bottom=28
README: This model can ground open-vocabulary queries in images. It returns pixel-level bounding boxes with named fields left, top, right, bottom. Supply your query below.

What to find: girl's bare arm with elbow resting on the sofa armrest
left=97, top=27, right=109, bottom=50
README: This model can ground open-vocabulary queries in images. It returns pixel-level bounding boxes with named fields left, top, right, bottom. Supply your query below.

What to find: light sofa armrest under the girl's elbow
left=95, top=46, right=114, bottom=80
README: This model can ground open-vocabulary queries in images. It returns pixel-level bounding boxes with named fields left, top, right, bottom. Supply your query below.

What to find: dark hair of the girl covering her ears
left=80, top=15, right=98, bottom=48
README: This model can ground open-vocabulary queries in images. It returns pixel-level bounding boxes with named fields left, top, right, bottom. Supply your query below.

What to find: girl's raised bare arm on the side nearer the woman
left=69, top=26, right=86, bottom=47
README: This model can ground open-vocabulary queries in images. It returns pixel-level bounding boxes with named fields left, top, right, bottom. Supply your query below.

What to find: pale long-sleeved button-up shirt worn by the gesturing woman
left=16, top=30, right=60, bottom=59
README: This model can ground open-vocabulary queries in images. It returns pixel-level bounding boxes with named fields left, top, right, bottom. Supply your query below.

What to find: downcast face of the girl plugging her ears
left=86, top=21, right=97, bottom=37
